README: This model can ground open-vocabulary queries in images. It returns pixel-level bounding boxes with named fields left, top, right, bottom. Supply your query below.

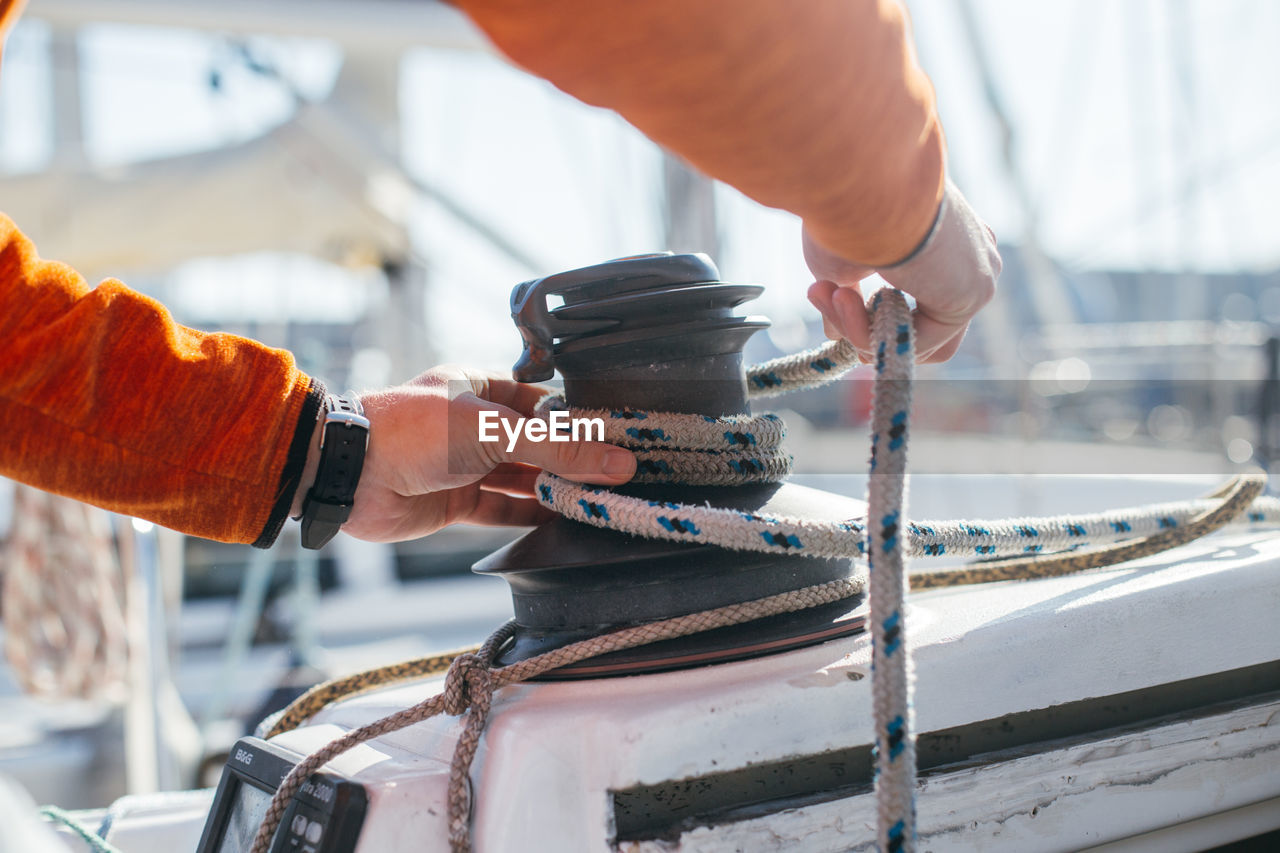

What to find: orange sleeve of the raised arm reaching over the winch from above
left=458, top=0, right=945, bottom=266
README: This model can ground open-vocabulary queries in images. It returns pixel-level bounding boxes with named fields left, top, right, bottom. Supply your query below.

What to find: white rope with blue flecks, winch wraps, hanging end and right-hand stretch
left=536, top=289, right=1280, bottom=853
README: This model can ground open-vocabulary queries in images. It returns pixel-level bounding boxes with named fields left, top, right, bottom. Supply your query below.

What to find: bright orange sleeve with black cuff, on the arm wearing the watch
left=0, top=215, right=323, bottom=547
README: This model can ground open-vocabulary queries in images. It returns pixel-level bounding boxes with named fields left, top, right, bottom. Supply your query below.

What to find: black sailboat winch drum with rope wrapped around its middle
left=474, top=254, right=864, bottom=679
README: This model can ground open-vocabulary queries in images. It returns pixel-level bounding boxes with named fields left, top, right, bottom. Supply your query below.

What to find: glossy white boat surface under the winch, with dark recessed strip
left=62, top=471, right=1280, bottom=853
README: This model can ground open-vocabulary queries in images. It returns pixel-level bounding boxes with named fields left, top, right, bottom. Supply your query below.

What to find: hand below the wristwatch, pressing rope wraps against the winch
left=327, top=366, right=636, bottom=542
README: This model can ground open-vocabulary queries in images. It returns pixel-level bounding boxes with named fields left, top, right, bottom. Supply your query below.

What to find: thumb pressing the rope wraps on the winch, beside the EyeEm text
left=463, top=394, right=636, bottom=485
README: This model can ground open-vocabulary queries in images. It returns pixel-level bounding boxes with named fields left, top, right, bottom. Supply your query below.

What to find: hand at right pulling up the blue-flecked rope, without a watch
left=803, top=181, right=1002, bottom=364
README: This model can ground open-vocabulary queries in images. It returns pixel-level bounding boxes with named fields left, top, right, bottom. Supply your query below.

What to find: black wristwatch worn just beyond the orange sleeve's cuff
left=302, top=392, right=369, bottom=549
